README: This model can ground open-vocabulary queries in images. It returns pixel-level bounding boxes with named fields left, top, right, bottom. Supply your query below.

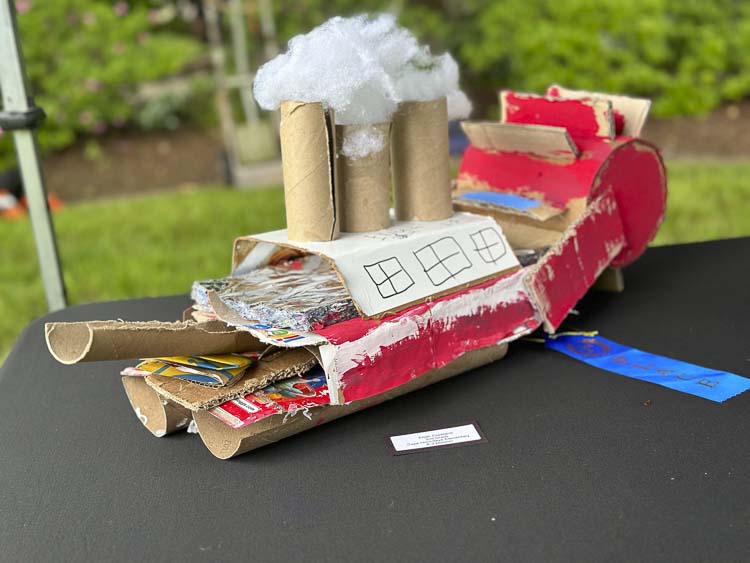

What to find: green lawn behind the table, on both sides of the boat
left=0, top=162, right=750, bottom=361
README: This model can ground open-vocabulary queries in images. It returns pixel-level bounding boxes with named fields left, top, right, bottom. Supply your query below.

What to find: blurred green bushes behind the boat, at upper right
left=256, top=0, right=750, bottom=116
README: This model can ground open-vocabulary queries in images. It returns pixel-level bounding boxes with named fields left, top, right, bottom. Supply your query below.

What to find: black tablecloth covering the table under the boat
left=0, top=239, right=750, bottom=561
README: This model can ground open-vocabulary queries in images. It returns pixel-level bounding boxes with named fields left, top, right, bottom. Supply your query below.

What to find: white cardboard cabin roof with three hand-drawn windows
left=234, top=213, right=519, bottom=317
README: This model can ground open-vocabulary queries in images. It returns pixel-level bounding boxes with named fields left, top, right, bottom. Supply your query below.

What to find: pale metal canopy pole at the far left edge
left=0, top=0, right=66, bottom=311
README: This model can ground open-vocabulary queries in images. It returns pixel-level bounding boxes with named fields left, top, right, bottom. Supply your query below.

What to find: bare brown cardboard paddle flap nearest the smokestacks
left=461, top=121, right=580, bottom=161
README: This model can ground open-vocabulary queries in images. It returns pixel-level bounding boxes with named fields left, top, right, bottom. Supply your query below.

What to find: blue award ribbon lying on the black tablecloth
left=547, top=335, right=750, bottom=403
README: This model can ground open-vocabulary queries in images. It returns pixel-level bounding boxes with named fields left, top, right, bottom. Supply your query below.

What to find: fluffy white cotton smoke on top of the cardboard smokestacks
left=253, top=14, right=471, bottom=158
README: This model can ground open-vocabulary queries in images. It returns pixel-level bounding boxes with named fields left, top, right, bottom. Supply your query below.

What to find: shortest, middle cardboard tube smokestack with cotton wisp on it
left=336, top=123, right=391, bottom=233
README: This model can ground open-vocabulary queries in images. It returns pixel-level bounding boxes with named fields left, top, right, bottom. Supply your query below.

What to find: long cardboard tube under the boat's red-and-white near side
left=193, top=344, right=508, bottom=459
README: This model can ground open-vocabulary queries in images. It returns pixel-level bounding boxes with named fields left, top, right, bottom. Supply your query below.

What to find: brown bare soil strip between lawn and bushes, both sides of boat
left=32, top=102, right=750, bottom=201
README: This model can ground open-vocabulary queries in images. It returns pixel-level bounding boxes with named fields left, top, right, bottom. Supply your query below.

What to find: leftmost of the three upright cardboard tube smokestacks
left=279, top=102, right=339, bottom=242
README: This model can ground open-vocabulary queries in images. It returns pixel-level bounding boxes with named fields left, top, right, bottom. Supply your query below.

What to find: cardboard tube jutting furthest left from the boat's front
left=44, top=321, right=266, bottom=364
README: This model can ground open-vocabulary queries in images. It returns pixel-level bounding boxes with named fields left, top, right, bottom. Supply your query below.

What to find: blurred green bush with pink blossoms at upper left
left=0, top=0, right=203, bottom=167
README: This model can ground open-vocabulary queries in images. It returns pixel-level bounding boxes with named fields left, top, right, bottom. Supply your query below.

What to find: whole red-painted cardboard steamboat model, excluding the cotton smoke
left=46, top=86, right=666, bottom=459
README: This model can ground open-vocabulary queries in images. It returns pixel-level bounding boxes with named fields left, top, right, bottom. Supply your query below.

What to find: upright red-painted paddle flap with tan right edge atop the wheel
left=500, top=90, right=615, bottom=142
